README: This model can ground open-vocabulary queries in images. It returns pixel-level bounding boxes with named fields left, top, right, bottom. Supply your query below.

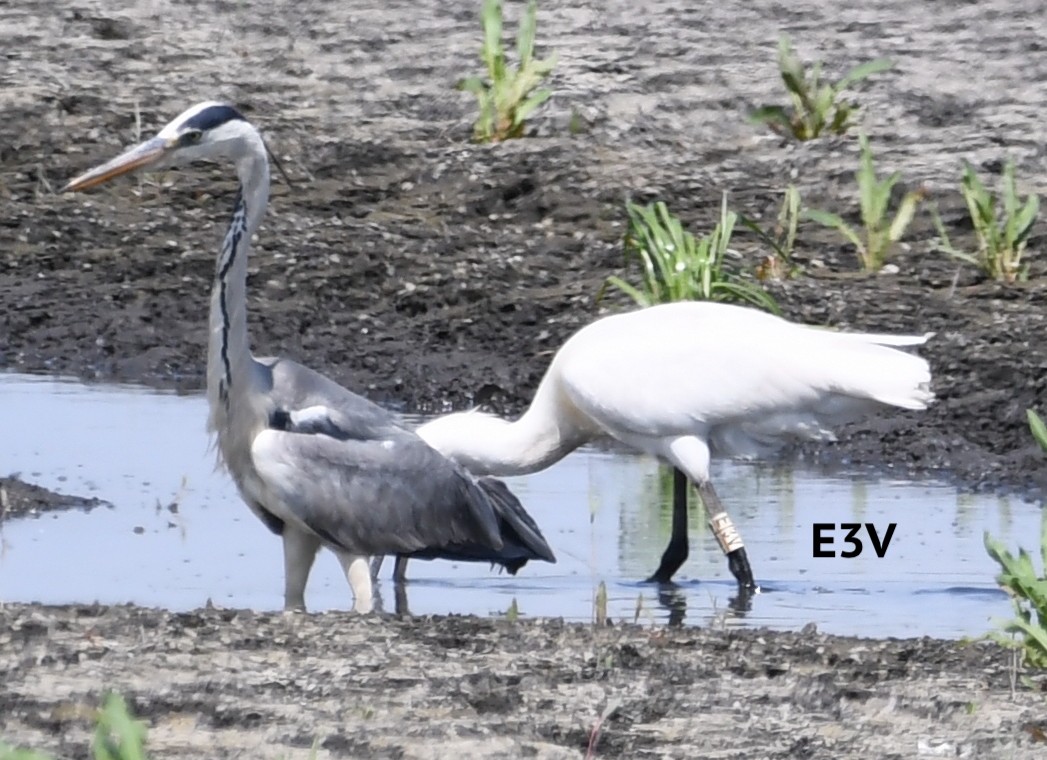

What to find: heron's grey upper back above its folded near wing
left=258, top=358, right=407, bottom=438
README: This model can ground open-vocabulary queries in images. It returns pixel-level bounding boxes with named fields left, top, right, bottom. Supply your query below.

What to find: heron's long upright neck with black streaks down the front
left=207, top=145, right=269, bottom=464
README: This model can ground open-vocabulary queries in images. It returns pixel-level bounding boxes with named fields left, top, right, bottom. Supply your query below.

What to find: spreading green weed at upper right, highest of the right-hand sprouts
left=750, top=35, right=894, bottom=140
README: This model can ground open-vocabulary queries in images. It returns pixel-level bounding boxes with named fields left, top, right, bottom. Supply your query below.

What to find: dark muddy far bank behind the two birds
left=0, top=0, right=1047, bottom=494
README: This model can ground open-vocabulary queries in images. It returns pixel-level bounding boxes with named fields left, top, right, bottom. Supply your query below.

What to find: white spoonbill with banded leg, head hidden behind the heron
left=373, top=301, right=934, bottom=597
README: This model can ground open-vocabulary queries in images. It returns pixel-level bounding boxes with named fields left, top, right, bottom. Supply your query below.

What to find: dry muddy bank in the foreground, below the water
left=0, top=605, right=1047, bottom=760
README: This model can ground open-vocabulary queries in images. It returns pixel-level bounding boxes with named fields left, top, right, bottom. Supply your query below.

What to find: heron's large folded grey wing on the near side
left=251, top=423, right=502, bottom=555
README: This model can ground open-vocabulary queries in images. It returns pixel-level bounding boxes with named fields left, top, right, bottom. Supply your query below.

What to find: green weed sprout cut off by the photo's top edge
left=459, top=0, right=556, bottom=142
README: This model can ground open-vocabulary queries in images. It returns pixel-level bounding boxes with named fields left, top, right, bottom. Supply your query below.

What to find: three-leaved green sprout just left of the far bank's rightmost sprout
left=804, top=135, right=923, bottom=272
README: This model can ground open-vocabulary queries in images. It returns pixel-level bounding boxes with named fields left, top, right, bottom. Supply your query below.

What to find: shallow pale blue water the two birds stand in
left=0, top=375, right=1040, bottom=636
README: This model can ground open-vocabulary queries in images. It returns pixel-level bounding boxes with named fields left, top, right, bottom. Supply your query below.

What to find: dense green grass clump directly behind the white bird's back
left=601, top=194, right=778, bottom=314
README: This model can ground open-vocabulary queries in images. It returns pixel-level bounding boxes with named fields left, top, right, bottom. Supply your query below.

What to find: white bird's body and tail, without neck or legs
left=551, top=303, right=933, bottom=455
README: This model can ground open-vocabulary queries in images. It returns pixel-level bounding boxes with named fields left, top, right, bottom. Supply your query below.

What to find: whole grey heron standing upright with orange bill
left=63, top=103, right=555, bottom=612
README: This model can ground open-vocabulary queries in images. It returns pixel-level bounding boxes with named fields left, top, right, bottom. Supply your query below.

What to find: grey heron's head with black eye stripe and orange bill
left=62, top=102, right=256, bottom=193
